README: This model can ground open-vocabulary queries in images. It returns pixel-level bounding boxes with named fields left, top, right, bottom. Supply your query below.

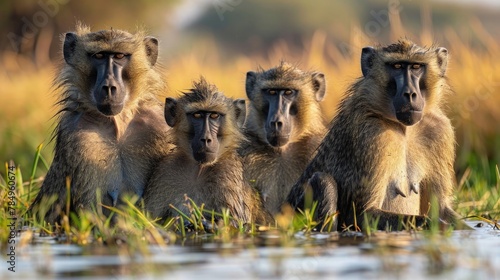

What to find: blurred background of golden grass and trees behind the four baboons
left=0, top=0, right=500, bottom=192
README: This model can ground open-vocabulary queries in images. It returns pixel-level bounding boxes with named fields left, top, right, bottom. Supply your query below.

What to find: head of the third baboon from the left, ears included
left=246, top=63, right=325, bottom=147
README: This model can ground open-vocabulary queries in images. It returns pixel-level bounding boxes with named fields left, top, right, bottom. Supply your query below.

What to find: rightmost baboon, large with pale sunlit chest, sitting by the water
left=287, top=39, right=464, bottom=229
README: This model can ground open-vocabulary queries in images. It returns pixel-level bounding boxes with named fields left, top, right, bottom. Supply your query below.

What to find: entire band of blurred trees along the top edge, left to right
left=0, top=0, right=500, bottom=65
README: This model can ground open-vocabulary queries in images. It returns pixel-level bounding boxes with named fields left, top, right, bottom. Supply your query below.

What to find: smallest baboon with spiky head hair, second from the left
left=144, top=77, right=270, bottom=223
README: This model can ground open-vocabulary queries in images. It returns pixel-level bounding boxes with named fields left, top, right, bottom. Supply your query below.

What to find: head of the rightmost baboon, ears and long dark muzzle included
left=361, top=40, right=447, bottom=126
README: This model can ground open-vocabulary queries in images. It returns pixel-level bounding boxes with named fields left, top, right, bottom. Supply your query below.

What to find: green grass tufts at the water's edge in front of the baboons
left=0, top=144, right=500, bottom=266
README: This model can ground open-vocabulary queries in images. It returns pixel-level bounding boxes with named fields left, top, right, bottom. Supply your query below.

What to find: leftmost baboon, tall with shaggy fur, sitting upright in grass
left=31, top=24, right=169, bottom=224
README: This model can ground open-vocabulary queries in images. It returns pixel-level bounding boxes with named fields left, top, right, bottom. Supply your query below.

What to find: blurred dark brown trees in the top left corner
left=0, top=0, right=179, bottom=67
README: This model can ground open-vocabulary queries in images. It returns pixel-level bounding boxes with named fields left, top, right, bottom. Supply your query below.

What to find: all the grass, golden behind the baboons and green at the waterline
left=0, top=12, right=500, bottom=255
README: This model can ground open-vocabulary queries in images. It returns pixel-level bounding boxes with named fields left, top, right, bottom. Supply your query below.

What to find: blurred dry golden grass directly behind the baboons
left=0, top=23, right=500, bottom=182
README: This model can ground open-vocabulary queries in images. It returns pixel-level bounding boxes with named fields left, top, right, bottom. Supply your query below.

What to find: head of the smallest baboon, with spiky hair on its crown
left=165, top=79, right=245, bottom=164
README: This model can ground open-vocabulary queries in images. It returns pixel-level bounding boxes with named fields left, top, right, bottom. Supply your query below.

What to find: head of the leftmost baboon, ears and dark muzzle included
left=63, top=30, right=158, bottom=116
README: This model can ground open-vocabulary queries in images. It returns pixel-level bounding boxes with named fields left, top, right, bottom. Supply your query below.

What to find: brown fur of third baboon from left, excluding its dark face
left=240, top=63, right=326, bottom=213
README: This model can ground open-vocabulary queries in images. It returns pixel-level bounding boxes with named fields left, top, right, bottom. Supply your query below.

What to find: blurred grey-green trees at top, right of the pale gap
left=185, top=0, right=500, bottom=55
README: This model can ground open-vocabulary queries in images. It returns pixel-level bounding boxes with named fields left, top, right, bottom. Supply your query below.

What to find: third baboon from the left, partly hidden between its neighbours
left=240, top=62, right=326, bottom=214
